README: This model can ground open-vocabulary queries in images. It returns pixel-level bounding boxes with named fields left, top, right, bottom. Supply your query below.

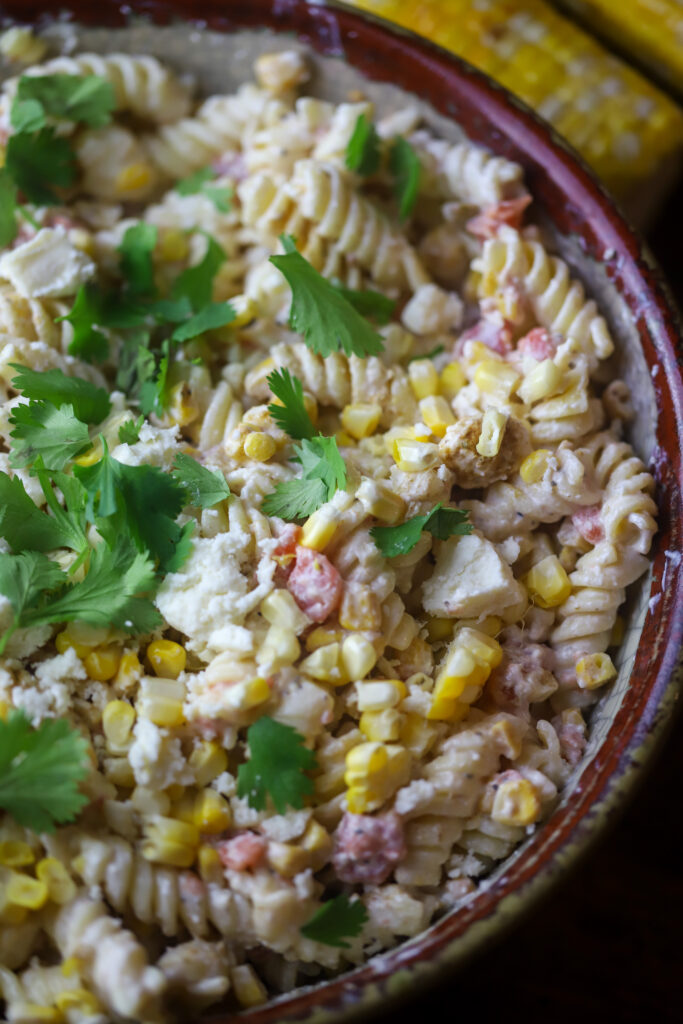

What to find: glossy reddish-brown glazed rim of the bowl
left=3, top=0, right=683, bottom=1024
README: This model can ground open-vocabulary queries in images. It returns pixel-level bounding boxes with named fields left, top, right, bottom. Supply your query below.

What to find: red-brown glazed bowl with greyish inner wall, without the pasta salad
left=3, top=0, right=683, bottom=1024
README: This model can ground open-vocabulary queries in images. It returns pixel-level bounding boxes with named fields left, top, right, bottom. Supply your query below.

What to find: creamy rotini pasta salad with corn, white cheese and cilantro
left=0, top=29, right=656, bottom=1024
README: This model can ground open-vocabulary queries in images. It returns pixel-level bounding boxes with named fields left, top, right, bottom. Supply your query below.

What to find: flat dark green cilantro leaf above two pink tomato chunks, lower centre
left=238, top=715, right=316, bottom=814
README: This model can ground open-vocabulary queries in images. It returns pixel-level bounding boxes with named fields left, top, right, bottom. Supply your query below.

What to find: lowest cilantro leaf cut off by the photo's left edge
left=0, top=711, right=90, bottom=833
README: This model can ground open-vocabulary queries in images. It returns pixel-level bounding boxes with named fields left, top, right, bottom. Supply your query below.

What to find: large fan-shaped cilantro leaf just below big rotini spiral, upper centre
left=270, top=234, right=384, bottom=356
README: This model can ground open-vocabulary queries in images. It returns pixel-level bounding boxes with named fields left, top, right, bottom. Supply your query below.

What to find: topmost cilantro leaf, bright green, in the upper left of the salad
left=10, top=74, right=116, bottom=131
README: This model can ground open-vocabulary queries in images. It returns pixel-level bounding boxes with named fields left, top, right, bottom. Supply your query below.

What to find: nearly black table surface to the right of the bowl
left=378, top=185, right=683, bottom=1024
